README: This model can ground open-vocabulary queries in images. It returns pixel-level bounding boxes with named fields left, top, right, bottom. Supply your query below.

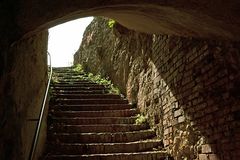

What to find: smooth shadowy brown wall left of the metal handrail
left=0, top=31, right=48, bottom=160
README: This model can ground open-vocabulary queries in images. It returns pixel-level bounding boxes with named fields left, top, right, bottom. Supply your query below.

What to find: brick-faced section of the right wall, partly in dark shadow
left=152, top=36, right=240, bottom=160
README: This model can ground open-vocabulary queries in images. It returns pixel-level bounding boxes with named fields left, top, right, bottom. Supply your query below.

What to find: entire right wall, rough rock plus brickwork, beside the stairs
left=74, top=18, right=240, bottom=160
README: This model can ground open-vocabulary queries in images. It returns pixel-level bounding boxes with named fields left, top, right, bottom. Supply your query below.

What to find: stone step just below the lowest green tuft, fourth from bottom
left=50, top=124, right=149, bottom=133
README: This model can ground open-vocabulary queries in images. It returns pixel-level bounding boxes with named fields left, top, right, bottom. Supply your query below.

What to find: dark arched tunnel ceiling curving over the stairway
left=16, top=0, right=240, bottom=40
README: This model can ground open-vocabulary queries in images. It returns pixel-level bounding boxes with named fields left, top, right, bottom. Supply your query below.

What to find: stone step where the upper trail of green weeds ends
left=52, top=93, right=121, bottom=99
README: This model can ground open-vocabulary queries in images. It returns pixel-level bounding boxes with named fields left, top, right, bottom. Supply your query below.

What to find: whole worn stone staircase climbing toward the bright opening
left=44, top=68, right=167, bottom=160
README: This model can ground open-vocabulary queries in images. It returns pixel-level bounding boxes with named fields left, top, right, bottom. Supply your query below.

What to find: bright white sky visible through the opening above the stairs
left=48, top=17, right=93, bottom=67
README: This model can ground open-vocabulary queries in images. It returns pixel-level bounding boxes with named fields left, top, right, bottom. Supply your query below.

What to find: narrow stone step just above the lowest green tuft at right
left=50, top=108, right=138, bottom=117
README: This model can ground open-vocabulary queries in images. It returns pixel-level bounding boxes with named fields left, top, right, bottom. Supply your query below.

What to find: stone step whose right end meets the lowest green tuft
left=49, top=116, right=136, bottom=125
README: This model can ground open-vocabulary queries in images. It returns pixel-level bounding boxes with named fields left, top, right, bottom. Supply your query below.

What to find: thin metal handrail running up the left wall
left=28, top=52, right=52, bottom=160
